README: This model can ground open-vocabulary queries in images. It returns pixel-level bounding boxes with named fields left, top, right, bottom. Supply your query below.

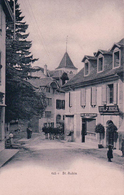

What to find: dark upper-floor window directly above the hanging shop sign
left=107, top=84, right=114, bottom=104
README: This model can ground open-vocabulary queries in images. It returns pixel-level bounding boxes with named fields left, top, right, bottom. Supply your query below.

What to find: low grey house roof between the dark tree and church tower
left=27, top=77, right=55, bottom=88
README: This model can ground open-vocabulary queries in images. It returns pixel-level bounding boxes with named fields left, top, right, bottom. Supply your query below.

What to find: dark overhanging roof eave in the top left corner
left=0, top=0, right=14, bottom=21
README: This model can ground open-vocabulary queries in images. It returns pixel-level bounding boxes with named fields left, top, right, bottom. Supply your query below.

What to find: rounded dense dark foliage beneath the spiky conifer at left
left=6, top=67, right=46, bottom=122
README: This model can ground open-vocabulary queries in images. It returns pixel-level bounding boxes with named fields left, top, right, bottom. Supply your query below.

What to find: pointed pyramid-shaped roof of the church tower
left=56, top=52, right=77, bottom=69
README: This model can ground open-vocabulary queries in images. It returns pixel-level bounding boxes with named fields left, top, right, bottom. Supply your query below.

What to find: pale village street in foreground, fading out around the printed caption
left=0, top=136, right=124, bottom=195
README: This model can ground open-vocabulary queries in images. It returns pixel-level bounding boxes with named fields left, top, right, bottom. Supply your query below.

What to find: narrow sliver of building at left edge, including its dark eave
left=0, top=0, right=13, bottom=151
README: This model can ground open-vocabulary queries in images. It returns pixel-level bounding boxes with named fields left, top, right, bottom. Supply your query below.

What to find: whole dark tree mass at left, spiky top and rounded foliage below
left=6, top=0, right=46, bottom=122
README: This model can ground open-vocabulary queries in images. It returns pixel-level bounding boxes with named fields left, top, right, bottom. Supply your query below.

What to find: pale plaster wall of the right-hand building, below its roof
left=65, top=80, right=124, bottom=145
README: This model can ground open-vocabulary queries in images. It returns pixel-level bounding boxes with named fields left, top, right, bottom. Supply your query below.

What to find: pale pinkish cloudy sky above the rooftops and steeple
left=18, top=0, right=124, bottom=70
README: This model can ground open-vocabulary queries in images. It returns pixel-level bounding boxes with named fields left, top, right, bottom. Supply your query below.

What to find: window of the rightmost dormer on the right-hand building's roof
left=113, top=48, right=121, bottom=68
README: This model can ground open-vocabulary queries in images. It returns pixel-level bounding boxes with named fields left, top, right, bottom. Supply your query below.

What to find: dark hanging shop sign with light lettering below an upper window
left=99, top=105, right=119, bottom=115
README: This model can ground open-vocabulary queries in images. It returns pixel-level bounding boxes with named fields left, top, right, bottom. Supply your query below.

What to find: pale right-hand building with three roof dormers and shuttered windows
left=62, top=39, right=124, bottom=147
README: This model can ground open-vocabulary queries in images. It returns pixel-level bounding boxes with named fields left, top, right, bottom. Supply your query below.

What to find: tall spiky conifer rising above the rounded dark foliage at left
left=6, top=0, right=38, bottom=74
